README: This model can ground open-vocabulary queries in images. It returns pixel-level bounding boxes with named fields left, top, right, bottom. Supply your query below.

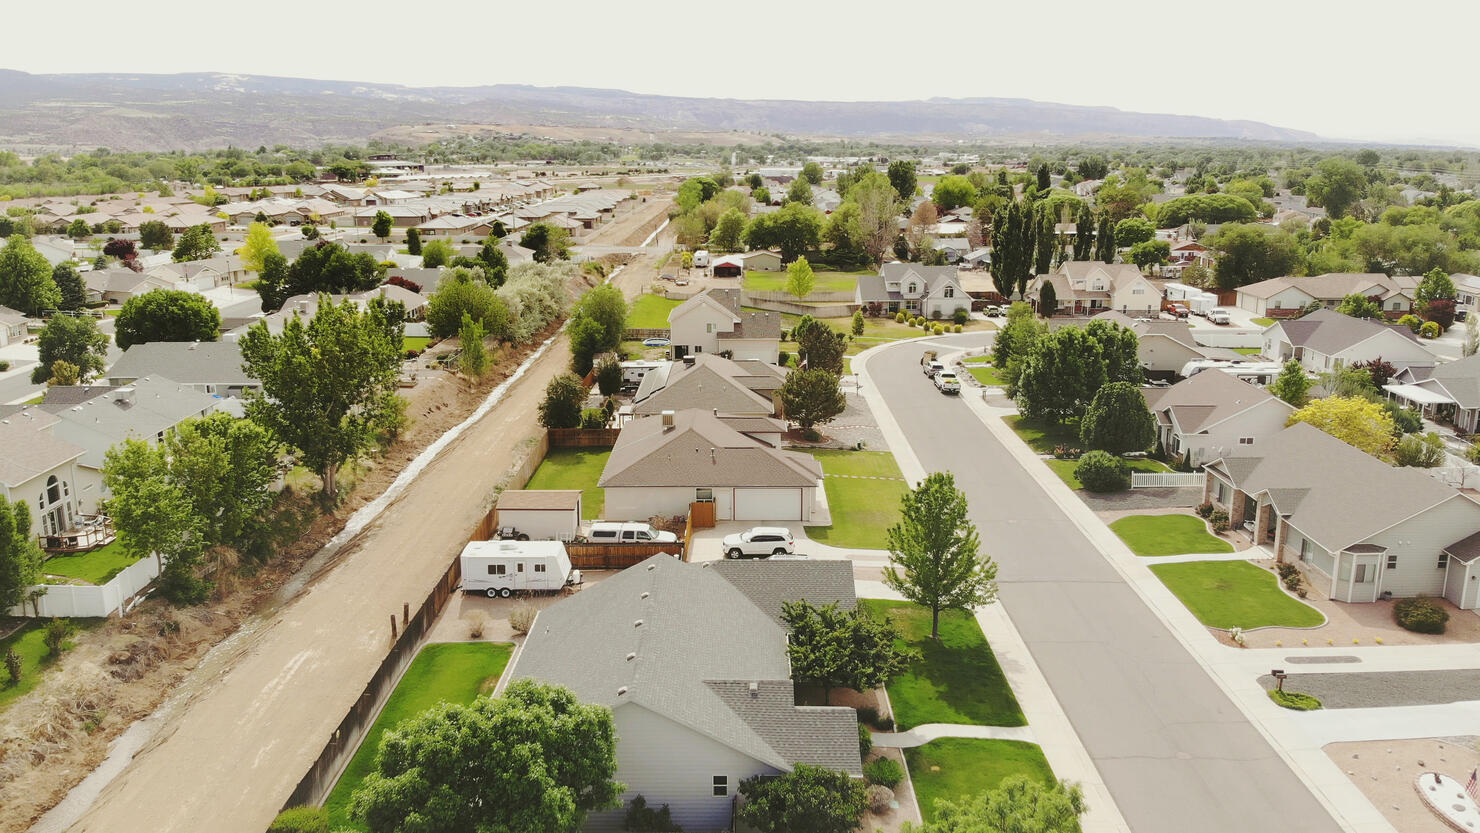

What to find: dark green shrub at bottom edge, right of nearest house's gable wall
left=736, top=763, right=867, bottom=833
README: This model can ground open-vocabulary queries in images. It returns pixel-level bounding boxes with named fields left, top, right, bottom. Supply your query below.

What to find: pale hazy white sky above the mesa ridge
left=11, top=0, right=1480, bottom=146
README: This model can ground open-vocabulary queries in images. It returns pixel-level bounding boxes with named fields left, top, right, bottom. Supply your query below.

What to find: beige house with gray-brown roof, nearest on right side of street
left=1203, top=423, right=1480, bottom=610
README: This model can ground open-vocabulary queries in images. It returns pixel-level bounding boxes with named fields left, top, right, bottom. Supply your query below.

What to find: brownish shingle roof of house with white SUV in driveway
left=598, top=410, right=823, bottom=488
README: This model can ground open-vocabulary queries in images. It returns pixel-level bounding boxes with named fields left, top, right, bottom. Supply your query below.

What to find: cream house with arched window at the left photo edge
left=0, top=408, right=83, bottom=536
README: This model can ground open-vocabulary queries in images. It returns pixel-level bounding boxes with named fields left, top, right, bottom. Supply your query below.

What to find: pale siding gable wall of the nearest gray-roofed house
left=585, top=703, right=778, bottom=833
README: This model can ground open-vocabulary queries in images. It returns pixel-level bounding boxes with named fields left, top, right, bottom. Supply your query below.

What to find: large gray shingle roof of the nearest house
left=509, top=555, right=861, bottom=774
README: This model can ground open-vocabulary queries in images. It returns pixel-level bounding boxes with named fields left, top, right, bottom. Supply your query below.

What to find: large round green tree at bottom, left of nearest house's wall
left=351, top=679, right=625, bottom=833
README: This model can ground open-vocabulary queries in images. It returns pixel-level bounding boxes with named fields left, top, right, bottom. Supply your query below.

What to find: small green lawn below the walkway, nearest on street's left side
left=904, top=738, right=1054, bottom=824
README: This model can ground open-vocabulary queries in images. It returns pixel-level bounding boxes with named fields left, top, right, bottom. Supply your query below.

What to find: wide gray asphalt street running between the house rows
left=867, top=336, right=1339, bottom=833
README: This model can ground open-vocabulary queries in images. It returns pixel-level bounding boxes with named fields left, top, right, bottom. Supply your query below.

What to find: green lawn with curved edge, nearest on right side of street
left=1151, top=561, right=1326, bottom=627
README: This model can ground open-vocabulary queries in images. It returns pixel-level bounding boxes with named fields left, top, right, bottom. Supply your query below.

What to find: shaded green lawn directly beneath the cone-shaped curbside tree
left=858, top=599, right=1027, bottom=731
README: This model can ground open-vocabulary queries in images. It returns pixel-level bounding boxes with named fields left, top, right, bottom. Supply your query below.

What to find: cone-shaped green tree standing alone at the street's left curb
left=884, top=472, right=998, bottom=639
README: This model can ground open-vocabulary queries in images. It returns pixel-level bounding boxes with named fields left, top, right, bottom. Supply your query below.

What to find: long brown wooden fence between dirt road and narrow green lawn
left=283, top=553, right=462, bottom=809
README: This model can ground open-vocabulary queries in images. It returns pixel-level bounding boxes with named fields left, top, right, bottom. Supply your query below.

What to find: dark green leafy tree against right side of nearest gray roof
left=781, top=599, right=919, bottom=704
